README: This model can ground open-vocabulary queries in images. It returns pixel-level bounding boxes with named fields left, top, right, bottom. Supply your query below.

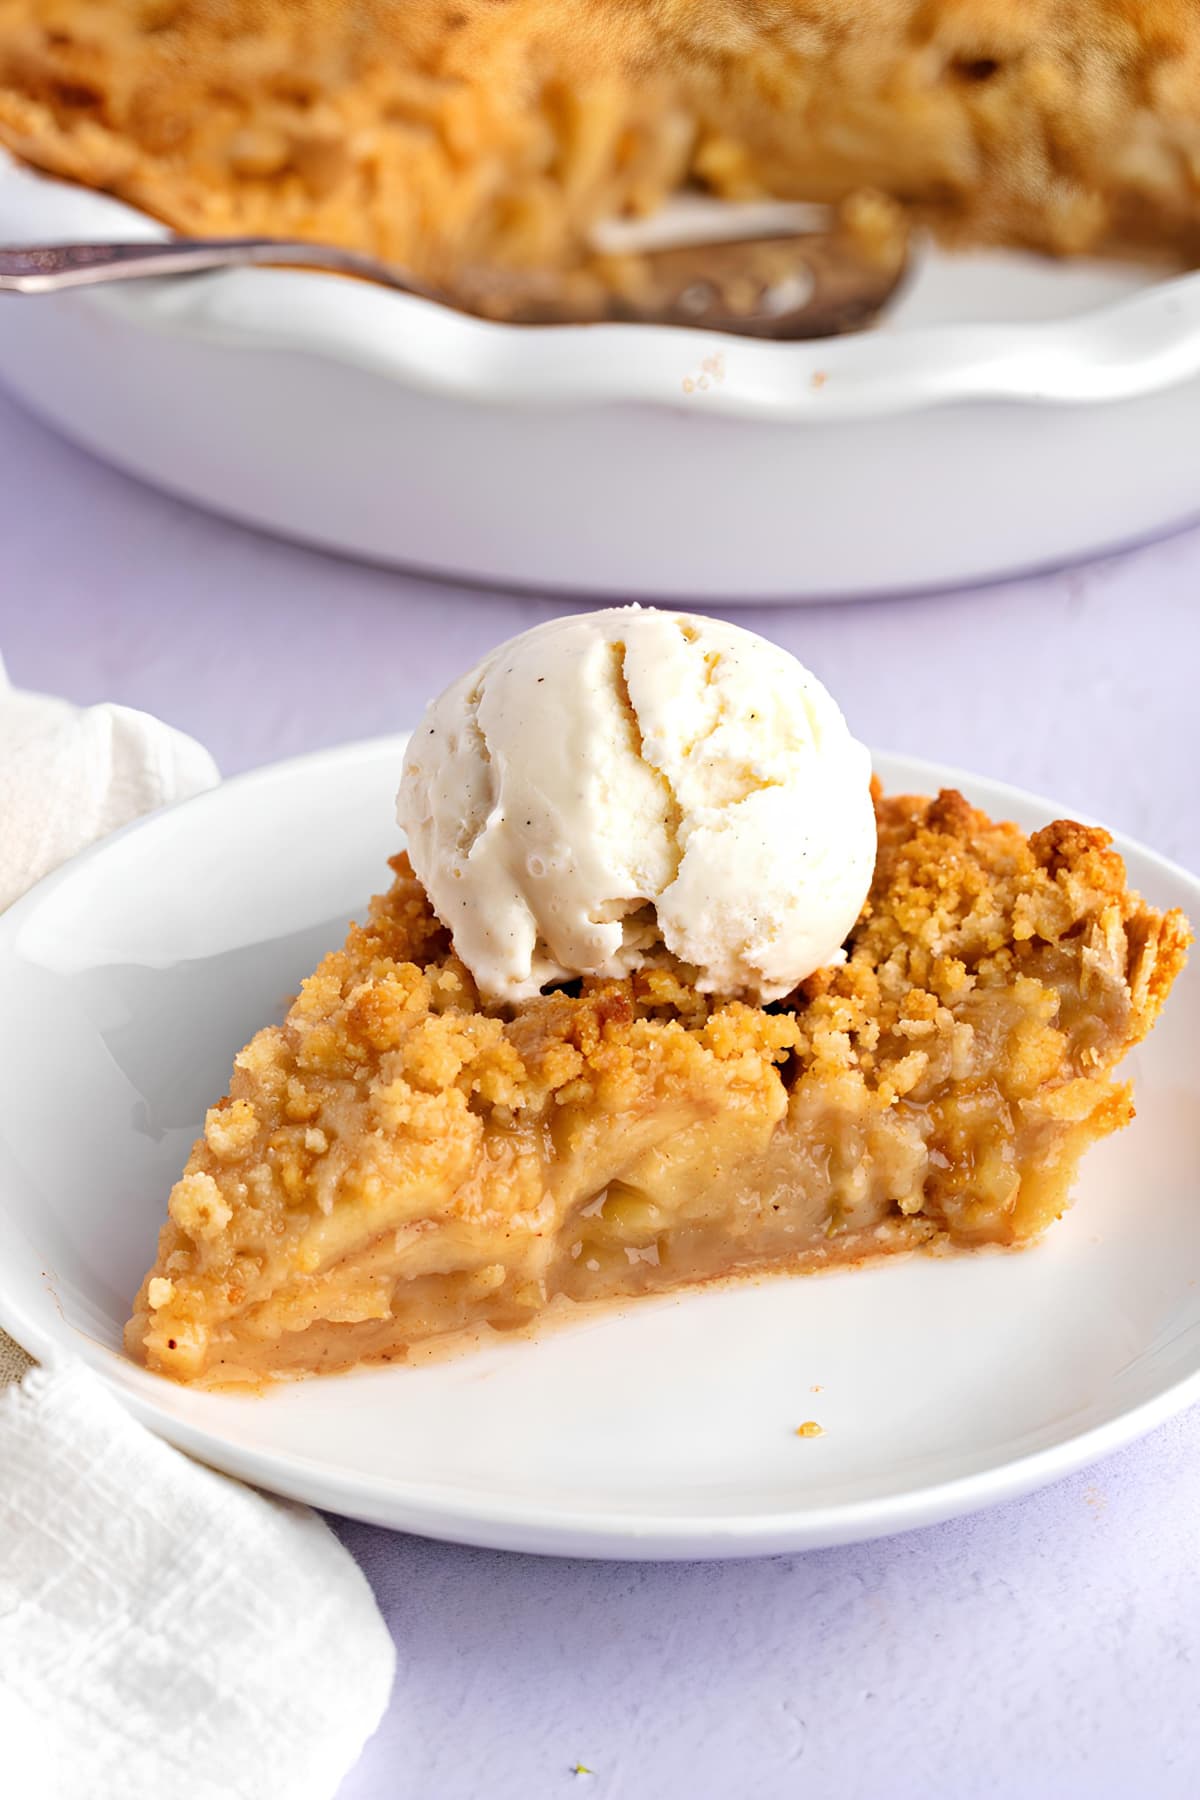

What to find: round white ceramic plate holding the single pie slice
left=0, top=740, right=1200, bottom=1557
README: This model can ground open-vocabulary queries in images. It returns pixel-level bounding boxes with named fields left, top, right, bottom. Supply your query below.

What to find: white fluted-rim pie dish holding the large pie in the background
left=0, top=153, right=1200, bottom=601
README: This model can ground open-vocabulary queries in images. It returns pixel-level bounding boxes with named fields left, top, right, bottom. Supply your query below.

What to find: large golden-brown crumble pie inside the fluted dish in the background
left=0, top=0, right=1200, bottom=281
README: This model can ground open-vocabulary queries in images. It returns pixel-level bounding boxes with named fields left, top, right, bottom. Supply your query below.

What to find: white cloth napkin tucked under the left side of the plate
left=0, top=662, right=394, bottom=1800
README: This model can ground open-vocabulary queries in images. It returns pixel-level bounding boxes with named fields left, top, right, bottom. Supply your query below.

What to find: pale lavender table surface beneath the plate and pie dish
left=0, top=383, right=1200, bottom=1800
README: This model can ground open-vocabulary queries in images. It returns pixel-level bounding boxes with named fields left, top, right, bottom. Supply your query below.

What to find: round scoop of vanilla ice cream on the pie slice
left=396, top=607, right=876, bottom=1003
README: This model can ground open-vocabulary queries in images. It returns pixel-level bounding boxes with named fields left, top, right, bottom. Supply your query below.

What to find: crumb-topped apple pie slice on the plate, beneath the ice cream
left=128, top=792, right=1189, bottom=1381
